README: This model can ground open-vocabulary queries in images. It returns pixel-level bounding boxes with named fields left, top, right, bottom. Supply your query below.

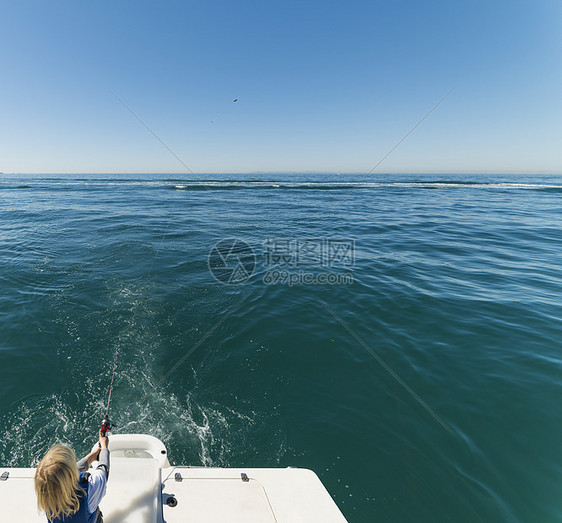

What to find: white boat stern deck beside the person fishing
left=0, top=435, right=346, bottom=523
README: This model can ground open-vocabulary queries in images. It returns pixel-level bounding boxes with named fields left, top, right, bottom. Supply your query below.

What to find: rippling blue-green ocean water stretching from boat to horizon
left=0, top=174, right=562, bottom=522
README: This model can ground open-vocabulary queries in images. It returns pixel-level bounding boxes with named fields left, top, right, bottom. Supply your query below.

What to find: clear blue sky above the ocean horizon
left=0, top=0, right=562, bottom=173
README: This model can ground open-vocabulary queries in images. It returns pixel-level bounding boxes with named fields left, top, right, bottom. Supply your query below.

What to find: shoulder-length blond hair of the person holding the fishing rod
left=35, top=445, right=85, bottom=520
